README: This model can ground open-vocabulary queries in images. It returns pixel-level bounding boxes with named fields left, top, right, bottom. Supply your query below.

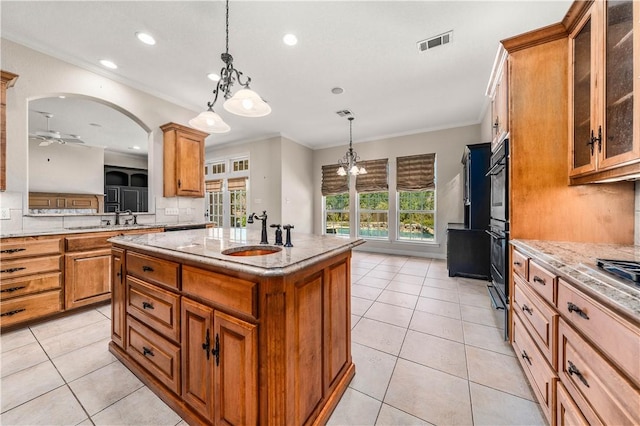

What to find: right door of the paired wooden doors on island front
left=213, top=311, right=258, bottom=426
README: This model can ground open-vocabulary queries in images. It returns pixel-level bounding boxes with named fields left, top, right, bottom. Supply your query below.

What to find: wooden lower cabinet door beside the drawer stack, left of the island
left=64, top=249, right=111, bottom=309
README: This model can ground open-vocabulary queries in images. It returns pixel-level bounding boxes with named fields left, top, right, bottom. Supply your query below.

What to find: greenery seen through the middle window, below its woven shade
left=358, top=192, right=389, bottom=238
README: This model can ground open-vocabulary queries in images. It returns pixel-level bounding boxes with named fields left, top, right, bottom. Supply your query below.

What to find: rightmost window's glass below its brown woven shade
left=398, top=190, right=436, bottom=241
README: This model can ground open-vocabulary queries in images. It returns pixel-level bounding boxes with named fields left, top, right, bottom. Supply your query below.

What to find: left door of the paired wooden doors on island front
left=181, top=297, right=215, bottom=421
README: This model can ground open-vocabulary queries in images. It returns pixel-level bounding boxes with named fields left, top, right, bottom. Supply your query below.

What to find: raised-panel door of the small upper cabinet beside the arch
left=176, top=133, right=204, bottom=197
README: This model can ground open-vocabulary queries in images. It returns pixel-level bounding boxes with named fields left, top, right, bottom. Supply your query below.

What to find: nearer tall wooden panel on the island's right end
left=296, top=271, right=324, bottom=425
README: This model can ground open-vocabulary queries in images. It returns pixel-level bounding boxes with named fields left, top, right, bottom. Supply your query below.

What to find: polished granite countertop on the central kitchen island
left=109, top=228, right=364, bottom=276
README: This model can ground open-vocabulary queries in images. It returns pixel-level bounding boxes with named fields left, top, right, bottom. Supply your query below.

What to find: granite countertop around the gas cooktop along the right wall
left=510, top=240, right=640, bottom=321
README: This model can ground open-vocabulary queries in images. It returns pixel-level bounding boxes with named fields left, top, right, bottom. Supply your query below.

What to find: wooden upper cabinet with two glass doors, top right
left=569, top=0, right=640, bottom=184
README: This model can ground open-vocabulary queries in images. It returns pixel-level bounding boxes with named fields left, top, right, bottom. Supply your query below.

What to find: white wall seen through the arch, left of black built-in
left=29, top=141, right=104, bottom=194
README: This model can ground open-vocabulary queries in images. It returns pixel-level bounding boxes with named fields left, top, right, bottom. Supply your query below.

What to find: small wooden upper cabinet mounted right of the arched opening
left=160, top=123, right=208, bottom=197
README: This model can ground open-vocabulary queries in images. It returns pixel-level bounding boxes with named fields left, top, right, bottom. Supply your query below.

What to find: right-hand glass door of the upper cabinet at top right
left=599, top=0, right=640, bottom=168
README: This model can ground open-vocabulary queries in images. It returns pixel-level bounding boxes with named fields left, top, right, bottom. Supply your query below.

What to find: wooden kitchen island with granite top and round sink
left=110, top=228, right=363, bottom=425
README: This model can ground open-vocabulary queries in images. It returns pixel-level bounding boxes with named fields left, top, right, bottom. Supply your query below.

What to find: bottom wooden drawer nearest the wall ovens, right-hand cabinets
left=511, top=315, right=557, bottom=424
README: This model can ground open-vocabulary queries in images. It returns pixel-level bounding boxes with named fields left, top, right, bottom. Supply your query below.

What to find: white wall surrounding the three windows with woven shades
left=313, top=124, right=484, bottom=258
